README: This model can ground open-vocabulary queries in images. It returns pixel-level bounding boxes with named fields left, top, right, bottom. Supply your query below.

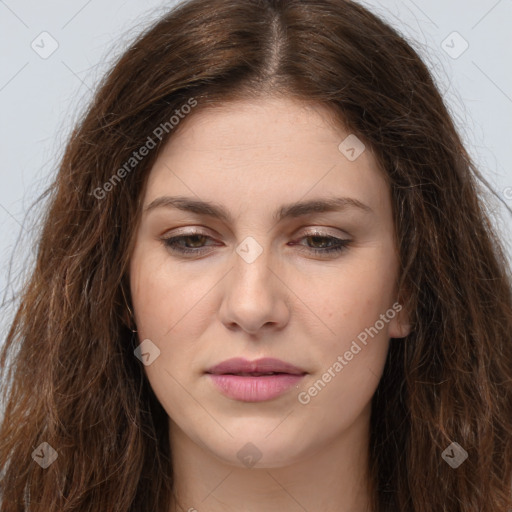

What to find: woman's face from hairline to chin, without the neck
left=130, top=99, right=408, bottom=467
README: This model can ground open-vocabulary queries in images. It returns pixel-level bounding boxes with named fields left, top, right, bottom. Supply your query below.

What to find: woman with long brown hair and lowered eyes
left=0, top=0, right=512, bottom=512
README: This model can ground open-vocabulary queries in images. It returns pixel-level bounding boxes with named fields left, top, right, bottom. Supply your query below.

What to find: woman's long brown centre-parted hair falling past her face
left=0, top=0, right=512, bottom=512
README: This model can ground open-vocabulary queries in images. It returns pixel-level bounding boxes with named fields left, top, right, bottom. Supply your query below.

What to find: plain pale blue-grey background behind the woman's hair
left=0, top=0, right=512, bottom=343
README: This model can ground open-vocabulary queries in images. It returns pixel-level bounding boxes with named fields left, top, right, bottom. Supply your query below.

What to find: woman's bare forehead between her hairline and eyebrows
left=144, top=98, right=389, bottom=219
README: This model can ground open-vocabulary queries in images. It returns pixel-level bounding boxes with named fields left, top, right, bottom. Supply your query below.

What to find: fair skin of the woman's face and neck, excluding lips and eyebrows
left=129, top=98, right=409, bottom=512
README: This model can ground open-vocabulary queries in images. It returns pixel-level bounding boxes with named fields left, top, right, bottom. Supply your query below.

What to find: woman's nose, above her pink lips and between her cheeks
left=219, top=244, right=291, bottom=335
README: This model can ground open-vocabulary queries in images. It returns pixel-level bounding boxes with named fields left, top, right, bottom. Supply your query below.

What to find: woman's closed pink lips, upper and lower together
left=206, top=357, right=307, bottom=402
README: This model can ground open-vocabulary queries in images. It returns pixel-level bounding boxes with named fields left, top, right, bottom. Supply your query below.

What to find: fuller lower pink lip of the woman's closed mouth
left=208, top=373, right=304, bottom=402
